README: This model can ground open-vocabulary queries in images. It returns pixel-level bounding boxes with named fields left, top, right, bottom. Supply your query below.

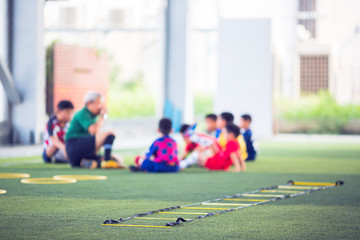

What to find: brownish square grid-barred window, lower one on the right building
left=300, top=55, right=329, bottom=94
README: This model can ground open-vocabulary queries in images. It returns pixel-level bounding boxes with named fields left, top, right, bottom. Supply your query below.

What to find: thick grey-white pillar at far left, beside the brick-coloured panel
left=11, top=0, right=46, bottom=144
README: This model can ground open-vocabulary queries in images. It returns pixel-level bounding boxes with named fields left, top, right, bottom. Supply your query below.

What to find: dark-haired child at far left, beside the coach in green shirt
left=42, top=100, right=74, bottom=163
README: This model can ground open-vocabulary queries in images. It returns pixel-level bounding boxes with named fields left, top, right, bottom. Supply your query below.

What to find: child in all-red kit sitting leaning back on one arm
left=199, top=124, right=246, bottom=172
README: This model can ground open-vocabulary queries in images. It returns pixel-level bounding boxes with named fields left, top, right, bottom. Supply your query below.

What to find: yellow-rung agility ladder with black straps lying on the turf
left=102, top=180, right=344, bottom=228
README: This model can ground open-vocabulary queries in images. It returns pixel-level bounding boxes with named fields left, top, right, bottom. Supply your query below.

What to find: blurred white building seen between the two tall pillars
left=44, top=0, right=165, bottom=97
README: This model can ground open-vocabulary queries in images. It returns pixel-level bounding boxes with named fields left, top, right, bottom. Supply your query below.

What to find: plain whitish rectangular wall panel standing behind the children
left=215, top=19, right=273, bottom=138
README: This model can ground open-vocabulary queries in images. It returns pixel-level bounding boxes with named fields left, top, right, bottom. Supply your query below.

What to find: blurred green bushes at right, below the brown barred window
left=276, top=91, right=360, bottom=133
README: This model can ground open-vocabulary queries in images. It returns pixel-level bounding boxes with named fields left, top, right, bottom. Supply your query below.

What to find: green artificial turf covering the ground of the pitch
left=0, top=142, right=360, bottom=239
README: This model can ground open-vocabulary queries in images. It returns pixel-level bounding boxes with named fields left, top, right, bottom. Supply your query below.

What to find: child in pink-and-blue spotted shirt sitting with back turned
left=129, top=118, right=179, bottom=173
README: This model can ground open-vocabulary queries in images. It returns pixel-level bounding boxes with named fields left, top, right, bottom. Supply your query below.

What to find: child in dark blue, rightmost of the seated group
left=240, top=114, right=256, bottom=161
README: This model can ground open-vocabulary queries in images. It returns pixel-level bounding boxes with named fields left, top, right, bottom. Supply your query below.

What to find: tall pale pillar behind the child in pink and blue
left=164, top=0, right=194, bottom=130
